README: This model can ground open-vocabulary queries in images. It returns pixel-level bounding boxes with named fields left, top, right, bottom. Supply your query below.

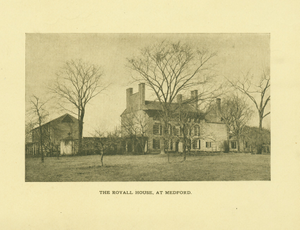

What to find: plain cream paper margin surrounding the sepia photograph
left=0, top=0, right=300, bottom=229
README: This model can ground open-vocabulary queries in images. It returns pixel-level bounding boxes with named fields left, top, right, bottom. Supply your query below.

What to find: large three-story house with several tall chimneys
left=121, top=83, right=228, bottom=152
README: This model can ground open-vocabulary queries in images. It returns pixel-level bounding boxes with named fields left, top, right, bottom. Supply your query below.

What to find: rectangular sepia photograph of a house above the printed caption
left=24, top=33, right=271, bottom=182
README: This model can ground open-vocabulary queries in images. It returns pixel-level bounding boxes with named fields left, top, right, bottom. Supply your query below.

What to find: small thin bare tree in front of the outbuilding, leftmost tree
left=28, top=95, right=49, bottom=162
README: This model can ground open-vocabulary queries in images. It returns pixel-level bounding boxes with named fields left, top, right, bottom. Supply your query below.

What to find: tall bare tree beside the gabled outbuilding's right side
left=51, top=60, right=108, bottom=154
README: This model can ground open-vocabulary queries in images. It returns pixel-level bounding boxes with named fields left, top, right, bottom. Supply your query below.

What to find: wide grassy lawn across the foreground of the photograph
left=25, top=153, right=271, bottom=182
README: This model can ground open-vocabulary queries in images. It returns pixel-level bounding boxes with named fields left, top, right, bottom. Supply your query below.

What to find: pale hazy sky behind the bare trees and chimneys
left=25, top=34, right=270, bottom=136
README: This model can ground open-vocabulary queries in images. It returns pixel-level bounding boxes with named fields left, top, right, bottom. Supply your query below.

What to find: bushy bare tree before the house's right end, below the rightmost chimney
left=220, top=94, right=253, bottom=151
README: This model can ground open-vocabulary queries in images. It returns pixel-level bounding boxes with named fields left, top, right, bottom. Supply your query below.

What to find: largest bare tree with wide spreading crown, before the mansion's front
left=128, top=41, right=216, bottom=154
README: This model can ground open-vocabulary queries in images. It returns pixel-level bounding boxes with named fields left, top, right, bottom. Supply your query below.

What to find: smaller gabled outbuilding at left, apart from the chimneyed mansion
left=26, top=113, right=78, bottom=155
